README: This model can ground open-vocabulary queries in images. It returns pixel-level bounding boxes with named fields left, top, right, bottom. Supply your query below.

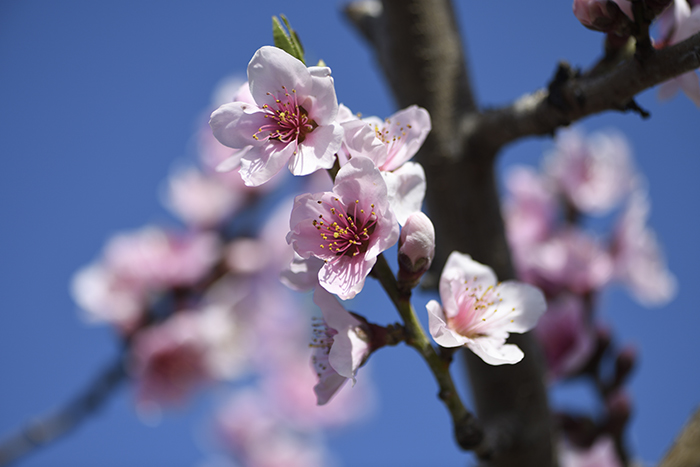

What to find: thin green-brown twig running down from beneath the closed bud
left=372, top=254, right=483, bottom=450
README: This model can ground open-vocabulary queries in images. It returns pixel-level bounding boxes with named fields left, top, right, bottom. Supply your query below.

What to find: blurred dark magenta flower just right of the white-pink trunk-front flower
left=535, top=294, right=596, bottom=381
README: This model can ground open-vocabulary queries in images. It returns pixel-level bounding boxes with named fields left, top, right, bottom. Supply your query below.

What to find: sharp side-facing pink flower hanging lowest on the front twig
left=311, top=287, right=371, bottom=405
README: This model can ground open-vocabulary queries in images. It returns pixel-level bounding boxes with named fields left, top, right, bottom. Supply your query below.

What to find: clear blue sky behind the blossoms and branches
left=0, top=0, right=700, bottom=467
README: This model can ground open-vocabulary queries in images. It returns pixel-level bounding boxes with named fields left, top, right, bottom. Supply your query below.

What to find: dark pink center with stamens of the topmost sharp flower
left=253, top=86, right=318, bottom=148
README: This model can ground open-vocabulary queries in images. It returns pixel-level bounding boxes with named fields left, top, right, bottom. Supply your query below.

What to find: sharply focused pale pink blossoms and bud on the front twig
left=210, top=47, right=545, bottom=403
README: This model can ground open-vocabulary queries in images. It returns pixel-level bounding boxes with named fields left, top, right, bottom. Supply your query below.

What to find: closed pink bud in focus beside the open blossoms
left=399, top=212, right=435, bottom=289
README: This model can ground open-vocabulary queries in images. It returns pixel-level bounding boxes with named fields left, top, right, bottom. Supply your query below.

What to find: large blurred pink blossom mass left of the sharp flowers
left=72, top=71, right=374, bottom=467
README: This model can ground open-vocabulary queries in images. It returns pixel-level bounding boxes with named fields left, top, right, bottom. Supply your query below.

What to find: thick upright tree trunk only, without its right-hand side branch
left=344, top=0, right=553, bottom=467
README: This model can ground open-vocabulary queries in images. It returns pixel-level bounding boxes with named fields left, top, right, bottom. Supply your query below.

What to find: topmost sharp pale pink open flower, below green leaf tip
left=209, top=46, right=343, bottom=186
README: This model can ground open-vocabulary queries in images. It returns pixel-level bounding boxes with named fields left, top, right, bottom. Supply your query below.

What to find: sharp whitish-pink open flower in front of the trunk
left=427, top=251, right=547, bottom=365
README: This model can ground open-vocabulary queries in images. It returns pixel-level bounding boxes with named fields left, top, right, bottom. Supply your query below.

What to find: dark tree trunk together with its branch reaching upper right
left=346, top=0, right=700, bottom=467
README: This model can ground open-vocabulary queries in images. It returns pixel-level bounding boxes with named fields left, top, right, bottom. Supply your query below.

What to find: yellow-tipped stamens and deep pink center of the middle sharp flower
left=313, top=198, right=377, bottom=259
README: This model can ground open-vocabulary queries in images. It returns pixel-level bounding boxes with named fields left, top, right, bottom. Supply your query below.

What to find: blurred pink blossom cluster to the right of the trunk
left=503, top=130, right=676, bottom=465
